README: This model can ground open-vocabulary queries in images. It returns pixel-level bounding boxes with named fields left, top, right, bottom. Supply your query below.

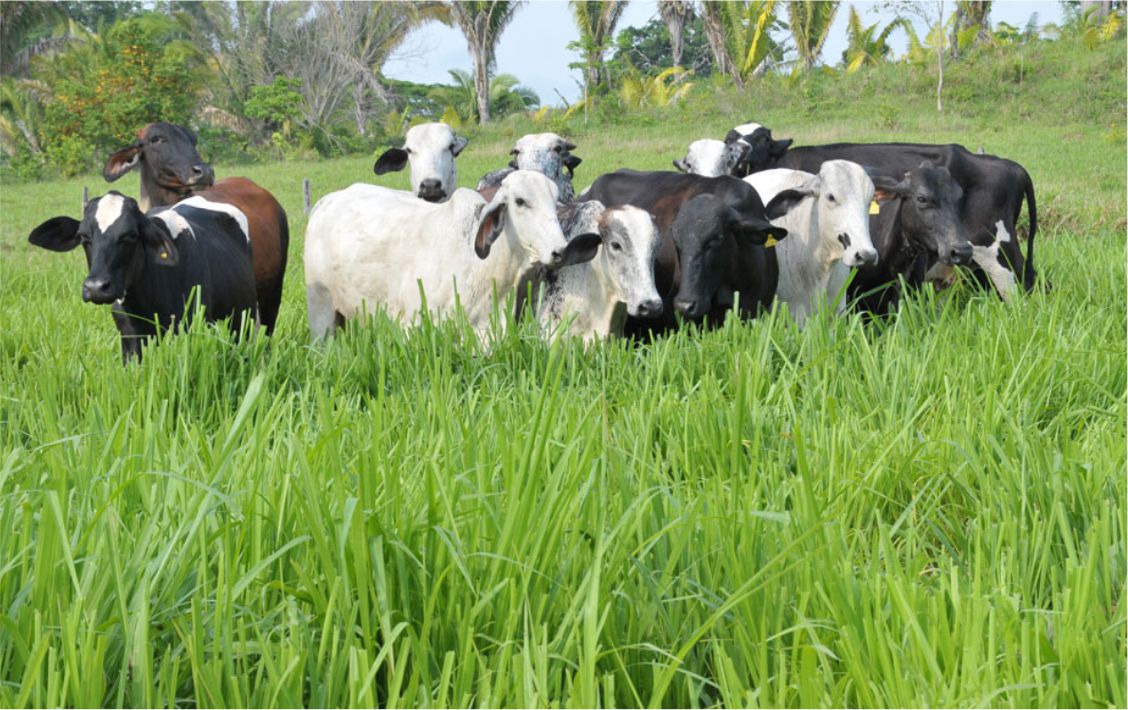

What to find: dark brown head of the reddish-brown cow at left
left=102, top=121, right=215, bottom=209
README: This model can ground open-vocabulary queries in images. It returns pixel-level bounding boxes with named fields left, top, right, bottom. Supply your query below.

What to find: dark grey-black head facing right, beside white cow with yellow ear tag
left=873, top=160, right=972, bottom=264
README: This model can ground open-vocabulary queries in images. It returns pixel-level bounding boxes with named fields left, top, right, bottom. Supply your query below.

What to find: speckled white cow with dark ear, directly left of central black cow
left=535, top=200, right=662, bottom=342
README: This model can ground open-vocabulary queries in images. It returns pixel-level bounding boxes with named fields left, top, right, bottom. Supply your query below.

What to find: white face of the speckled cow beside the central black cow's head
left=598, top=207, right=662, bottom=317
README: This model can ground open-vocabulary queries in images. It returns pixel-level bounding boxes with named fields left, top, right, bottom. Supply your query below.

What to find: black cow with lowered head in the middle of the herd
left=581, top=169, right=802, bottom=334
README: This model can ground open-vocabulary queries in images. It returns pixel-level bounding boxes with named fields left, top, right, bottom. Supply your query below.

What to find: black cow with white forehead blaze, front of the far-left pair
left=28, top=192, right=256, bottom=361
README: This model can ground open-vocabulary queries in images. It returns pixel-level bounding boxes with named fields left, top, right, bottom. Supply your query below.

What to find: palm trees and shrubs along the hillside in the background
left=0, top=0, right=1125, bottom=182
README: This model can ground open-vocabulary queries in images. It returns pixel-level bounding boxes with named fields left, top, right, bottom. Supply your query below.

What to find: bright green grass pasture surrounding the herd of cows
left=0, top=42, right=1128, bottom=708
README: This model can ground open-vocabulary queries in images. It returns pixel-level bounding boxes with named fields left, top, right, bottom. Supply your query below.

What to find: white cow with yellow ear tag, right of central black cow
left=744, top=160, right=878, bottom=326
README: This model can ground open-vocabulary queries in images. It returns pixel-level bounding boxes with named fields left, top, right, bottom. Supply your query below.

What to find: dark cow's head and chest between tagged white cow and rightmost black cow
left=847, top=161, right=972, bottom=314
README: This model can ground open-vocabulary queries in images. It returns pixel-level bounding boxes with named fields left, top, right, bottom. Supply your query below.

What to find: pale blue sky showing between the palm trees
left=384, top=0, right=1063, bottom=106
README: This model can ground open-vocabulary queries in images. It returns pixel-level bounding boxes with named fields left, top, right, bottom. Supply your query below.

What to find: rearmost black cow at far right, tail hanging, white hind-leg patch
left=773, top=143, right=1038, bottom=298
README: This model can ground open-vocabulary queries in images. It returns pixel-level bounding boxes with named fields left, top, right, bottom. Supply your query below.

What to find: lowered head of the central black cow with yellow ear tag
left=671, top=191, right=795, bottom=318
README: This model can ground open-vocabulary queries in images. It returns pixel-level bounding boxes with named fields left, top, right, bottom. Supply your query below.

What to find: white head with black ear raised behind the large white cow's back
left=372, top=123, right=468, bottom=202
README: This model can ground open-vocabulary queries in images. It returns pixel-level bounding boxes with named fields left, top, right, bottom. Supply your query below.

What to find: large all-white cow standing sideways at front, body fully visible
left=305, top=170, right=599, bottom=340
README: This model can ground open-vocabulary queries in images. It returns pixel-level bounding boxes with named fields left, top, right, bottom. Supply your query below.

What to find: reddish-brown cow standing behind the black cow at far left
left=102, top=122, right=290, bottom=334
